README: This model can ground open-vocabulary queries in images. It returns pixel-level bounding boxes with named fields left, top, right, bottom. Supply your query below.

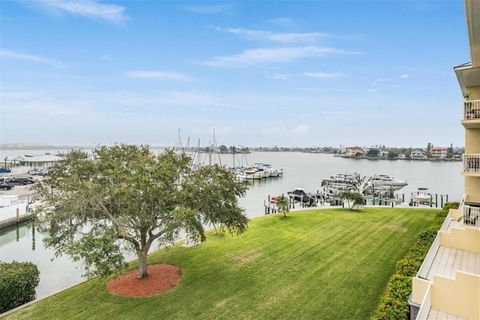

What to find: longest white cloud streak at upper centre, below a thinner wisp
left=205, top=46, right=358, bottom=67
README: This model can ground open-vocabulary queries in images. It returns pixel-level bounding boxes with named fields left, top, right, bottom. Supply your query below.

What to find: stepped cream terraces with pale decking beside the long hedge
left=409, top=209, right=480, bottom=320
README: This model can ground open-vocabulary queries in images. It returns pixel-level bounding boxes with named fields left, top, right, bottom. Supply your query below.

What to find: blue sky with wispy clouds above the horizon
left=0, top=0, right=470, bottom=146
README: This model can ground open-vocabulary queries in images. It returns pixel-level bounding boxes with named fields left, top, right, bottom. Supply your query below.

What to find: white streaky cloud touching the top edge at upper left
left=34, top=0, right=127, bottom=23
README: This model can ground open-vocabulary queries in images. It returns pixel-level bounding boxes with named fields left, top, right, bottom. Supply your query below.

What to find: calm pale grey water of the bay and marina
left=0, top=150, right=463, bottom=297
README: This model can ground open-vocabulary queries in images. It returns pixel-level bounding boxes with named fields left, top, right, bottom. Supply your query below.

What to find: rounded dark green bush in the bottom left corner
left=0, top=261, right=40, bottom=313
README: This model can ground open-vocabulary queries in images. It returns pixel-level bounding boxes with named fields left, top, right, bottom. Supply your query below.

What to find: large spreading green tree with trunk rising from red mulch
left=36, top=145, right=248, bottom=277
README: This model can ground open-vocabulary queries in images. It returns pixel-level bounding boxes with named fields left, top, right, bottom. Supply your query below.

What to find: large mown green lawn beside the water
left=7, top=208, right=435, bottom=320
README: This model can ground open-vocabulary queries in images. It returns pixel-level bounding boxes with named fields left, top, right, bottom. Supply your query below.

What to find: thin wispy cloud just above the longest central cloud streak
left=218, top=28, right=332, bottom=43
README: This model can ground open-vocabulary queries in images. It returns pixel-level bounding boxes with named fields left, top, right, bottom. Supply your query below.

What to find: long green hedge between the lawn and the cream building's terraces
left=371, top=202, right=459, bottom=320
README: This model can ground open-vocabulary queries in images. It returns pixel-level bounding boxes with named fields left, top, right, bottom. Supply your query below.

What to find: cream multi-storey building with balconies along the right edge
left=409, top=0, right=480, bottom=320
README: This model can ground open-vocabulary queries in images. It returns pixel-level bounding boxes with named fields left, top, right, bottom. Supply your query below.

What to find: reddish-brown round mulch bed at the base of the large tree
left=107, top=264, right=182, bottom=297
